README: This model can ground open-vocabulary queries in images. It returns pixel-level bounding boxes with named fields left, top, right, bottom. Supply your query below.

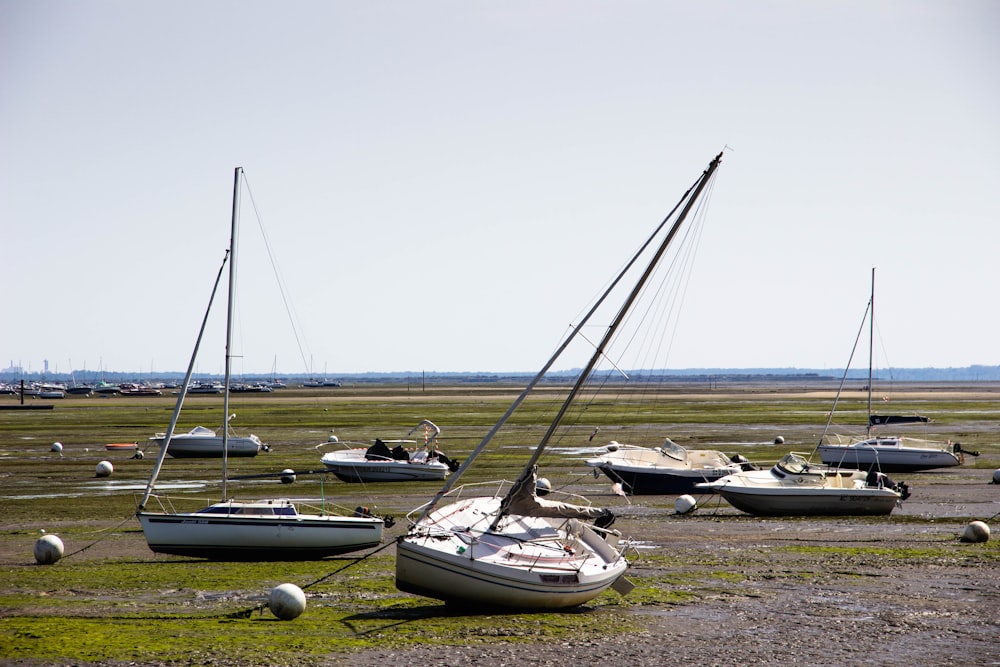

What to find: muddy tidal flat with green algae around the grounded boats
left=0, top=382, right=1000, bottom=667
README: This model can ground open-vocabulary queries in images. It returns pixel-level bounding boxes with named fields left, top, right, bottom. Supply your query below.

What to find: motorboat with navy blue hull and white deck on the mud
left=586, top=438, right=752, bottom=495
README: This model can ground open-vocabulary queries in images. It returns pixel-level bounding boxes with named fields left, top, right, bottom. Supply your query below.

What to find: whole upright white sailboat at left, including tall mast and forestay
left=136, top=167, right=385, bottom=560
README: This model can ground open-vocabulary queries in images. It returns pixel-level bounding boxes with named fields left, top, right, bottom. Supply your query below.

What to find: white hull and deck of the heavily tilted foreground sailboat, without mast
left=396, top=497, right=628, bottom=609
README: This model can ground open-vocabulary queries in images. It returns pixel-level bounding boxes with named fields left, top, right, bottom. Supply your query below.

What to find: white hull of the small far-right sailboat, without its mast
left=817, top=437, right=962, bottom=472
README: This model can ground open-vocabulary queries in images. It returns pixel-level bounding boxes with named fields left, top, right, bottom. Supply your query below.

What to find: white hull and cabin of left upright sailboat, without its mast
left=136, top=501, right=383, bottom=561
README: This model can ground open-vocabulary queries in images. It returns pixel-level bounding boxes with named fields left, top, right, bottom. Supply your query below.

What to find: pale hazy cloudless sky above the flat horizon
left=0, top=0, right=1000, bottom=377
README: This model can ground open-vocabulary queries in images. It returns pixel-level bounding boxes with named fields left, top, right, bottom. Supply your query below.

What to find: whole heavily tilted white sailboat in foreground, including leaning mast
left=396, top=153, right=722, bottom=609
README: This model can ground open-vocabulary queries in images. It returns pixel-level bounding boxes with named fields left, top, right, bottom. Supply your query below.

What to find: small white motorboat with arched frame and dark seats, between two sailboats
left=320, top=419, right=458, bottom=482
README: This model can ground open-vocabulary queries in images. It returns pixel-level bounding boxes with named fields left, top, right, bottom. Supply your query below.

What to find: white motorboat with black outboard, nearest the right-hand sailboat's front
left=698, top=452, right=910, bottom=516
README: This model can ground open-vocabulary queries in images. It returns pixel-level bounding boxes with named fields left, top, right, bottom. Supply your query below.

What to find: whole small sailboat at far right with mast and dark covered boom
left=817, top=268, right=979, bottom=472
